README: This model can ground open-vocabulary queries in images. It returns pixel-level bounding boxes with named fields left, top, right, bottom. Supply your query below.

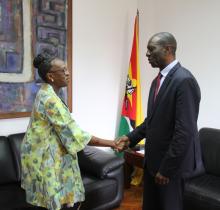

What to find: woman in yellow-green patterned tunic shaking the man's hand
left=21, top=52, right=117, bottom=210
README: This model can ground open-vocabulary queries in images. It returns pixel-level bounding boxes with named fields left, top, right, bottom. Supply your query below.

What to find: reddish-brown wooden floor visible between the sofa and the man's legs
left=113, top=186, right=143, bottom=210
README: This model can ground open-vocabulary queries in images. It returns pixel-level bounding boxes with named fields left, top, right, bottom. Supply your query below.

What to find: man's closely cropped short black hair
left=151, top=32, right=177, bottom=55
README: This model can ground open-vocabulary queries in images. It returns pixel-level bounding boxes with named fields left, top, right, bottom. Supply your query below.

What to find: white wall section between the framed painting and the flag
left=73, top=0, right=137, bottom=138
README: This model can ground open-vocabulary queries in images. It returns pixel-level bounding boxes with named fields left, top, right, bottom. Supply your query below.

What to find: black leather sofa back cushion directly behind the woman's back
left=8, top=133, right=25, bottom=181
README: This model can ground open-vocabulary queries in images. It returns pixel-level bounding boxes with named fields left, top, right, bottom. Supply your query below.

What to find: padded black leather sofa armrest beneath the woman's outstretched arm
left=78, top=146, right=124, bottom=179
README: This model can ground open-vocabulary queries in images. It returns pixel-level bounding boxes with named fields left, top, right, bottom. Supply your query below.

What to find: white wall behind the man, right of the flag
left=139, top=0, right=220, bottom=128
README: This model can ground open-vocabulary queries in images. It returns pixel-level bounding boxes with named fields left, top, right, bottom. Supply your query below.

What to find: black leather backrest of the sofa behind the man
left=199, top=128, right=220, bottom=176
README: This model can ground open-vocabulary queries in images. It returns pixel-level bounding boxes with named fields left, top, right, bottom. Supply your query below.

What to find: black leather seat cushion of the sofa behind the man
left=184, top=174, right=220, bottom=210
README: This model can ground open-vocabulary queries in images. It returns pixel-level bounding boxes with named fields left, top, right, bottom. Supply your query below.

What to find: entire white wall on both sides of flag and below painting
left=0, top=0, right=220, bottom=138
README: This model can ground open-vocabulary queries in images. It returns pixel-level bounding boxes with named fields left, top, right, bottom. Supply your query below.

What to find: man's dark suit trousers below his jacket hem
left=143, top=169, right=183, bottom=210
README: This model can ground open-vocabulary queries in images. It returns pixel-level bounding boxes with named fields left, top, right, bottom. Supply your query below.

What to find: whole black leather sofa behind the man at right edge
left=184, top=128, right=220, bottom=210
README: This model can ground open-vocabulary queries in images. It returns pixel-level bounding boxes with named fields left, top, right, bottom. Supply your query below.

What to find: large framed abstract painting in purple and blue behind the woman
left=0, top=0, right=72, bottom=119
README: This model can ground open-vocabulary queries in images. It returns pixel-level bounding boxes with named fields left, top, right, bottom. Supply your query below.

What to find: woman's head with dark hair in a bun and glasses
left=33, top=52, right=69, bottom=89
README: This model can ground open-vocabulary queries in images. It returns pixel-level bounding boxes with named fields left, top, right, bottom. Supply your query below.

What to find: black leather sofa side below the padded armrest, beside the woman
left=80, top=174, right=118, bottom=210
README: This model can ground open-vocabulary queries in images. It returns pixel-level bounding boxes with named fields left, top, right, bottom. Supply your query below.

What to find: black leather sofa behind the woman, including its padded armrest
left=0, top=133, right=124, bottom=210
